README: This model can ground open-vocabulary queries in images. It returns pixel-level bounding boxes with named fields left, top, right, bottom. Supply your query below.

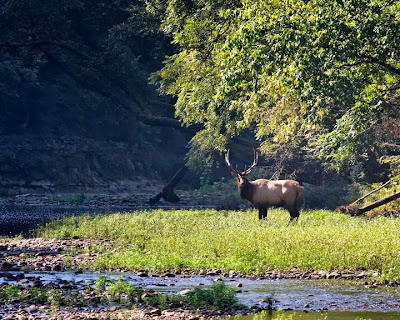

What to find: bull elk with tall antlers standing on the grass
left=225, top=150, right=304, bottom=221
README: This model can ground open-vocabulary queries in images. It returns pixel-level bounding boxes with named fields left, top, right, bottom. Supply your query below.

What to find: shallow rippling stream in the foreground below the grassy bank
left=0, top=272, right=400, bottom=320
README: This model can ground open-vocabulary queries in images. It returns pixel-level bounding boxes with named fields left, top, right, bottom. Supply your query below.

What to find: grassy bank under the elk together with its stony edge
left=0, top=209, right=400, bottom=286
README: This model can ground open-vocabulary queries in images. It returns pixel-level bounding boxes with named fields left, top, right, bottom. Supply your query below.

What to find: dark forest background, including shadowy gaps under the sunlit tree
left=0, top=0, right=399, bottom=194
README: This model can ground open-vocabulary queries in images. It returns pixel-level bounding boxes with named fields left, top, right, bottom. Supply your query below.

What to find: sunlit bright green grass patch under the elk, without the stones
left=37, top=210, right=400, bottom=280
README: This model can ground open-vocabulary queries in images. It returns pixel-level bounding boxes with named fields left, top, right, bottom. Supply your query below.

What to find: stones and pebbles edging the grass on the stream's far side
left=0, top=237, right=390, bottom=286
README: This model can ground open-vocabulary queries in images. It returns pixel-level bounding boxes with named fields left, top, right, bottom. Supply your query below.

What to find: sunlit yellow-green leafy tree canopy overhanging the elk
left=147, top=0, right=400, bottom=176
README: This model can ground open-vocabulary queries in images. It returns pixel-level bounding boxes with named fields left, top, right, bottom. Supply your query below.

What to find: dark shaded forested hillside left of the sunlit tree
left=0, top=1, right=194, bottom=192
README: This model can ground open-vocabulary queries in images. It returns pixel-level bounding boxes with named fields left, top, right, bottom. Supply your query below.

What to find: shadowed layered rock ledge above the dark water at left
left=0, top=129, right=185, bottom=195
